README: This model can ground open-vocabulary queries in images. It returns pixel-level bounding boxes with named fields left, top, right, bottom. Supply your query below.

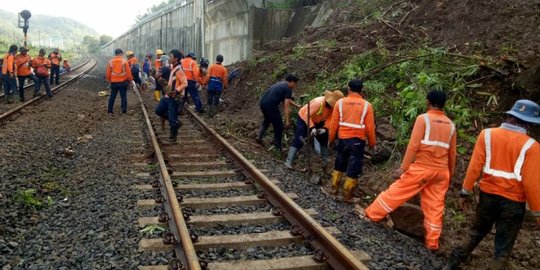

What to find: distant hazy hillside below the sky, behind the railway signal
left=0, top=10, right=98, bottom=48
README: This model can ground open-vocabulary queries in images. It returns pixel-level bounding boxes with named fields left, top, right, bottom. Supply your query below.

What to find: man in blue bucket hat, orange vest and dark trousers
left=444, top=100, right=540, bottom=270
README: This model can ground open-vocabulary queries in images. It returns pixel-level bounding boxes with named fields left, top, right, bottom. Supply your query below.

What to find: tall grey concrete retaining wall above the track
left=100, top=0, right=331, bottom=64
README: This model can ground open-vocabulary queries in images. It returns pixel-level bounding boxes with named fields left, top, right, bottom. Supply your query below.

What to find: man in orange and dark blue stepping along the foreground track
left=155, top=50, right=188, bottom=143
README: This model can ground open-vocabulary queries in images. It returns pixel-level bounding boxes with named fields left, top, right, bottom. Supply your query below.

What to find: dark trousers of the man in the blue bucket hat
left=451, top=191, right=525, bottom=262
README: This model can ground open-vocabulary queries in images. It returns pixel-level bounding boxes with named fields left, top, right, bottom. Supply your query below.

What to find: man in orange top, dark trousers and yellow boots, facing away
left=329, top=79, right=375, bottom=203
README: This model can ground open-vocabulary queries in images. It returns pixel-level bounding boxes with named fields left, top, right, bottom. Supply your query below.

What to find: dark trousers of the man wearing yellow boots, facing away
left=334, top=138, right=366, bottom=179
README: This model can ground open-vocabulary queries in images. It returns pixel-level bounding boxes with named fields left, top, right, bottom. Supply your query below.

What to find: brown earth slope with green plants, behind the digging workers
left=208, top=0, right=540, bottom=269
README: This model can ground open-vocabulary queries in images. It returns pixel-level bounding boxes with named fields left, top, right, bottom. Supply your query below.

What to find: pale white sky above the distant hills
left=0, top=0, right=163, bottom=37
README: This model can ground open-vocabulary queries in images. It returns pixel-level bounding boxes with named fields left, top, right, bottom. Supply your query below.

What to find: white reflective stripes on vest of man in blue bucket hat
left=484, top=129, right=534, bottom=182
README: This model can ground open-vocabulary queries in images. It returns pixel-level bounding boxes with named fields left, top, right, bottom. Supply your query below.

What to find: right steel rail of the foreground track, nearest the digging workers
left=185, top=109, right=368, bottom=270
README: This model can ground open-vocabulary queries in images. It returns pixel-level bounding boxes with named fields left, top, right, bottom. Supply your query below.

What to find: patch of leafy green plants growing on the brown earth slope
left=308, top=48, right=486, bottom=153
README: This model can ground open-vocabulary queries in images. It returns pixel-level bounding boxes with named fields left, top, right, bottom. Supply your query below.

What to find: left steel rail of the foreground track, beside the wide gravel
left=135, top=89, right=201, bottom=270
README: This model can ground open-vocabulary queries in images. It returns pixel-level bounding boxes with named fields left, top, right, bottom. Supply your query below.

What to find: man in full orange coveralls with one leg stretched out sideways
left=365, top=90, right=457, bottom=250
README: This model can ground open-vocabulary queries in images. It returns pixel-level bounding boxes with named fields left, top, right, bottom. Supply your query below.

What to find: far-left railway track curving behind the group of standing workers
left=0, top=56, right=98, bottom=122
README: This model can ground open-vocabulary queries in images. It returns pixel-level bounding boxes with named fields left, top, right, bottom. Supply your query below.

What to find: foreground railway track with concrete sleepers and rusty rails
left=135, top=87, right=370, bottom=270
